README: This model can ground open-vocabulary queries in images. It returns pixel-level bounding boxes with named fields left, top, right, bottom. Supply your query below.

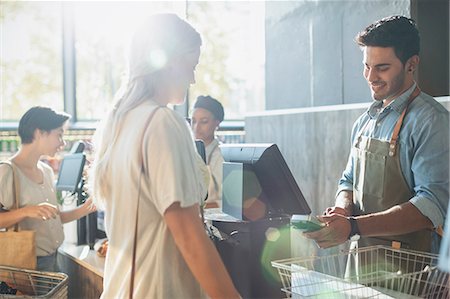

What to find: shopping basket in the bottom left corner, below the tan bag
left=0, top=266, right=68, bottom=299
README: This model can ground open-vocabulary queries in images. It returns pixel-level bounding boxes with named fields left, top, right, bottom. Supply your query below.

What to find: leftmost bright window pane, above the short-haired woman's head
left=0, top=1, right=64, bottom=121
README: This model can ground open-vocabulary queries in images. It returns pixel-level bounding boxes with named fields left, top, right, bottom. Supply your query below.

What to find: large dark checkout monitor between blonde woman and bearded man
left=220, top=144, right=311, bottom=221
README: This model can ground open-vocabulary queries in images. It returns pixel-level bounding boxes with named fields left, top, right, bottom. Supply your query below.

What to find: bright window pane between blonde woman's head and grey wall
left=187, top=1, right=265, bottom=119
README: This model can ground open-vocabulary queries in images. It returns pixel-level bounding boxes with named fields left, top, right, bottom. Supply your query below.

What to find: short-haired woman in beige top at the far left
left=0, top=107, right=95, bottom=271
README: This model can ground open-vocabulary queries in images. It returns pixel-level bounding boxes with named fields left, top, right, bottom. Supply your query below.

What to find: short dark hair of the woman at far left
left=19, top=106, right=70, bottom=144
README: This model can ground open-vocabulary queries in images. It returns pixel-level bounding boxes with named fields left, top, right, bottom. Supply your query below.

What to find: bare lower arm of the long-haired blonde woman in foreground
left=164, top=203, right=240, bottom=298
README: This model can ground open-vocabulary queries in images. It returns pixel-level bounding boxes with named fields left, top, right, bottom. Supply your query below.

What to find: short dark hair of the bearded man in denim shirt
left=355, top=16, right=420, bottom=64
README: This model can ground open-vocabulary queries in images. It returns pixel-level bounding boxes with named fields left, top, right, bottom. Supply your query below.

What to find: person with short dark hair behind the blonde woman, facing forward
left=191, top=96, right=224, bottom=208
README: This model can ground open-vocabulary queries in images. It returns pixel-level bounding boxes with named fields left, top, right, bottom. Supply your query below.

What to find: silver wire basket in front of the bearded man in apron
left=272, top=246, right=450, bottom=299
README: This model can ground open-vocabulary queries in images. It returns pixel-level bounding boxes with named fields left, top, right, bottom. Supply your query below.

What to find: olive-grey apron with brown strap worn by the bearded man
left=352, top=86, right=432, bottom=252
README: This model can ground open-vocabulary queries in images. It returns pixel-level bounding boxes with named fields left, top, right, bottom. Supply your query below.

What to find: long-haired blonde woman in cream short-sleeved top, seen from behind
left=89, top=14, right=239, bottom=298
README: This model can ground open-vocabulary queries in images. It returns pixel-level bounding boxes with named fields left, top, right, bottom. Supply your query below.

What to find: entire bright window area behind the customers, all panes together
left=0, top=1, right=265, bottom=122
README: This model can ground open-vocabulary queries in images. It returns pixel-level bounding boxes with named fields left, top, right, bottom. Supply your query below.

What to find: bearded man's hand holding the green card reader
left=303, top=213, right=351, bottom=248
